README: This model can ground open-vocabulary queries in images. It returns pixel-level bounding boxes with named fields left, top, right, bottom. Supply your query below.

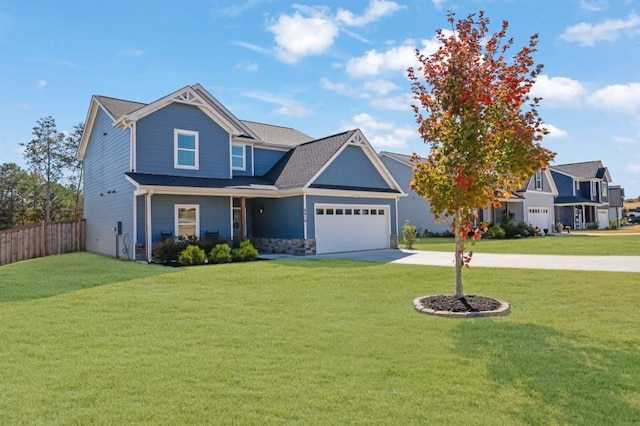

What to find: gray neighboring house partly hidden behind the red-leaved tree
left=379, top=151, right=558, bottom=232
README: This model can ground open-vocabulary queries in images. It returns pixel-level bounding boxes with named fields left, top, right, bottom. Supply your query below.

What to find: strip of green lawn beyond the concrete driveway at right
left=408, top=234, right=640, bottom=256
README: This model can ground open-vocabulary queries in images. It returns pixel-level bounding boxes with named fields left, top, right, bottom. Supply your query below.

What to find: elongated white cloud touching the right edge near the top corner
left=560, top=13, right=640, bottom=46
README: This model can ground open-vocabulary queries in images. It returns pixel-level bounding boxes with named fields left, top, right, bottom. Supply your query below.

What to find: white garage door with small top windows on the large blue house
left=314, top=204, right=391, bottom=254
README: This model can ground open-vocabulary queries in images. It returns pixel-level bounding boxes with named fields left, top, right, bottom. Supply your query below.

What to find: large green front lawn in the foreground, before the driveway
left=0, top=253, right=640, bottom=425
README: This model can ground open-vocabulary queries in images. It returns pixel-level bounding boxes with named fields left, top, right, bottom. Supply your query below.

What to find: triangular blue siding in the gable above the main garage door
left=313, top=146, right=390, bottom=189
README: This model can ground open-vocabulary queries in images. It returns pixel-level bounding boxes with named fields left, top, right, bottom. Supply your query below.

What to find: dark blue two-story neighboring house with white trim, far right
left=550, top=161, right=611, bottom=229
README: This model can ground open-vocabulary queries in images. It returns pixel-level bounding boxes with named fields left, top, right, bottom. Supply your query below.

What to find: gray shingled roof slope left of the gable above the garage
left=269, top=130, right=357, bottom=189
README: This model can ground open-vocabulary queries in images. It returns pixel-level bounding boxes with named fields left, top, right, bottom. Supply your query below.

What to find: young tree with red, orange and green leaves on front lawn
left=408, top=12, right=555, bottom=299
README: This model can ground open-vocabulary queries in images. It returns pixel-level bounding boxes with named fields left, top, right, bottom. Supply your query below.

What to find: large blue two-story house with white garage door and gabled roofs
left=78, top=84, right=404, bottom=261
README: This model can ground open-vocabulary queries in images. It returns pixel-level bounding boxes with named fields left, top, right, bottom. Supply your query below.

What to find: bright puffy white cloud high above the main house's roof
left=268, top=8, right=338, bottom=64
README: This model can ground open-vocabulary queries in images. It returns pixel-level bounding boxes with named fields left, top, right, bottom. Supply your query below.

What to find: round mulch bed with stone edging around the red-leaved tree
left=413, top=294, right=510, bottom=318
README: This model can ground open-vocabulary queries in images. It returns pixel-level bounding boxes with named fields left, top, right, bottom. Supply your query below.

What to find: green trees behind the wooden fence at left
left=0, top=116, right=84, bottom=230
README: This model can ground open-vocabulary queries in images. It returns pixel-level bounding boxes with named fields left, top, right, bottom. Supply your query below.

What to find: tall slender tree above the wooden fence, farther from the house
left=20, top=116, right=72, bottom=222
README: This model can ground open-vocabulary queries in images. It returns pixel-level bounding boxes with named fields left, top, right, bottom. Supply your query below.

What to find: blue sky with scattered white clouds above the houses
left=0, top=0, right=640, bottom=197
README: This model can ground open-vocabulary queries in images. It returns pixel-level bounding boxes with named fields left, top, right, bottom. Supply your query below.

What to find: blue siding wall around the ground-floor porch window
left=149, top=194, right=232, bottom=242
